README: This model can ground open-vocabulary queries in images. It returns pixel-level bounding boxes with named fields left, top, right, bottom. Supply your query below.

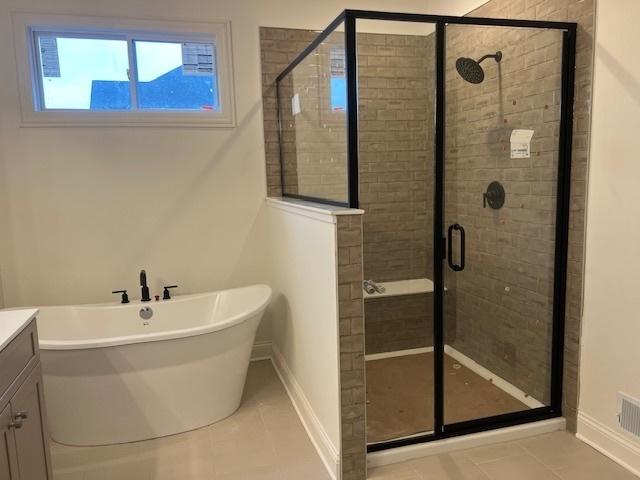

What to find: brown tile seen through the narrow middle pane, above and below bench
left=357, top=33, right=435, bottom=354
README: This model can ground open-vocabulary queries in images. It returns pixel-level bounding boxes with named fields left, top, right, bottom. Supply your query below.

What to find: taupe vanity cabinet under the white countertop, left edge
left=0, top=317, right=53, bottom=480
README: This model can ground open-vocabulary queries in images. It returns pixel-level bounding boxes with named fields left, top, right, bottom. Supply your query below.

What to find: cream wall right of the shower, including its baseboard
left=578, top=0, right=640, bottom=472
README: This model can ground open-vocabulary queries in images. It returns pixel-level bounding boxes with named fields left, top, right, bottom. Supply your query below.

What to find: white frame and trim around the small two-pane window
left=13, top=13, right=236, bottom=127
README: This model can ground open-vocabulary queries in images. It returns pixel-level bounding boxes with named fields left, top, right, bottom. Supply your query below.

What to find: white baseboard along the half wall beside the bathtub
left=271, top=344, right=340, bottom=480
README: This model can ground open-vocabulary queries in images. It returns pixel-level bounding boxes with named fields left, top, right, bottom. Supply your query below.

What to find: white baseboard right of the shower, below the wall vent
left=576, top=412, right=640, bottom=477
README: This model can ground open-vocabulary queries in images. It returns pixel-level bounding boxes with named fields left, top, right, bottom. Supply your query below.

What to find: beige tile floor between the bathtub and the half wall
left=51, top=361, right=330, bottom=480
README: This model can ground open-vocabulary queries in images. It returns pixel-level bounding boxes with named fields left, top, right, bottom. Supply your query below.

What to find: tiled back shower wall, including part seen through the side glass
left=260, top=28, right=435, bottom=353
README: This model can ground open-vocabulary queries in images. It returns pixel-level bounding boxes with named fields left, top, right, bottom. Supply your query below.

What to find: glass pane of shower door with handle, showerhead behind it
left=443, top=25, right=563, bottom=424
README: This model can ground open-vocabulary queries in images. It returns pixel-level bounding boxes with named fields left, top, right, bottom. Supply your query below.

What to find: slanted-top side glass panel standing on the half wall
left=277, top=27, right=349, bottom=204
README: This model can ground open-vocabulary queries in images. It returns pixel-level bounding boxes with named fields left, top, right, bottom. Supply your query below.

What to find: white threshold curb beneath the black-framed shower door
left=367, top=417, right=566, bottom=468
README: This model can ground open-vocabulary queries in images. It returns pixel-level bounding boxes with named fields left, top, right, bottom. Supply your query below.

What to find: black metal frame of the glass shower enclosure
left=276, top=10, right=577, bottom=452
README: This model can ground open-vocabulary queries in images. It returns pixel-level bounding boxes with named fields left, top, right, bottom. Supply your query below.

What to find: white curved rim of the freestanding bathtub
left=32, top=284, right=273, bottom=351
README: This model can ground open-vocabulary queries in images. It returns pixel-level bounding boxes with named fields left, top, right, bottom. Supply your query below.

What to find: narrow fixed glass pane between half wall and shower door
left=356, top=20, right=435, bottom=444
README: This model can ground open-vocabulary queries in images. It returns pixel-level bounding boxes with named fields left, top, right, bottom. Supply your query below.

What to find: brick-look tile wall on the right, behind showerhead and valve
left=446, top=0, right=595, bottom=431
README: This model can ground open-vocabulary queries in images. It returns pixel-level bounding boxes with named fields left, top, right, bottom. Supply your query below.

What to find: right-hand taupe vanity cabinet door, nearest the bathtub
left=10, top=365, right=52, bottom=480
